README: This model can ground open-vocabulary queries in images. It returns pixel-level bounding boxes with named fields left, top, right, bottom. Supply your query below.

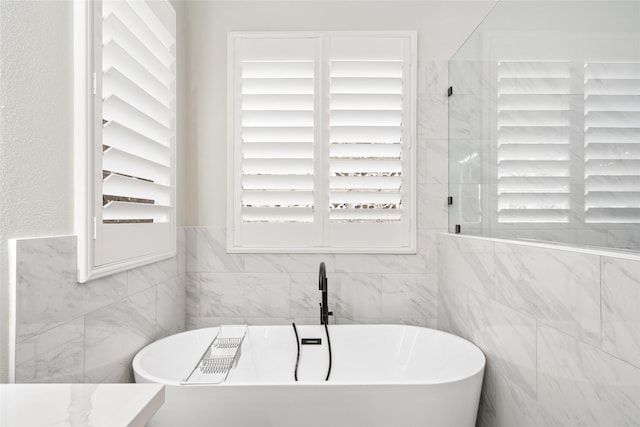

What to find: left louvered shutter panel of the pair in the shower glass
left=497, top=61, right=571, bottom=227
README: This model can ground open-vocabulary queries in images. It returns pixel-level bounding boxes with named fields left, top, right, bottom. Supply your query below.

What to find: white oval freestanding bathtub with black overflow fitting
left=133, top=325, right=485, bottom=427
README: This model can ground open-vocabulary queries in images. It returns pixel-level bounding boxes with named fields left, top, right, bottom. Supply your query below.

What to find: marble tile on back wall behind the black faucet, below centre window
left=182, top=227, right=437, bottom=329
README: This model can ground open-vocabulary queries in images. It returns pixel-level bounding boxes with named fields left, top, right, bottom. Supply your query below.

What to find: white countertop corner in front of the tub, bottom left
left=0, top=384, right=164, bottom=427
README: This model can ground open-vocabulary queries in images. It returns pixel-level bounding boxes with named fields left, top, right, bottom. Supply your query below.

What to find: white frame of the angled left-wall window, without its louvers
left=74, top=0, right=176, bottom=283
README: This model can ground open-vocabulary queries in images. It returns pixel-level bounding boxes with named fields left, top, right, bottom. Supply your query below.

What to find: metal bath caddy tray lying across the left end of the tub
left=182, top=325, right=247, bottom=384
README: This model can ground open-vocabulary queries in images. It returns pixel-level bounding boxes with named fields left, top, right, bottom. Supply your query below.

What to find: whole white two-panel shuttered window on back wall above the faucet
left=228, top=32, right=416, bottom=253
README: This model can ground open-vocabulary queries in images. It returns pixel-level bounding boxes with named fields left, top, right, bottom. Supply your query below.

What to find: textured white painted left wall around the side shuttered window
left=0, top=0, right=185, bottom=382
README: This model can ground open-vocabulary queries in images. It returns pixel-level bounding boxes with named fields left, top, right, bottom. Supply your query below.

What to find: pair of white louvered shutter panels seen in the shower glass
left=497, top=60, right=640, bottom=224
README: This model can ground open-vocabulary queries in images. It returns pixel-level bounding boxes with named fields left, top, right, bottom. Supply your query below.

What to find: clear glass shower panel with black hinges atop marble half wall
left=449, top=1, right=640, bottom=251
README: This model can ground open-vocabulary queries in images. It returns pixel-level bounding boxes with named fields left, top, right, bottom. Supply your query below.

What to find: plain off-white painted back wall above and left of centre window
left=187, top=1, right=494, bottom=226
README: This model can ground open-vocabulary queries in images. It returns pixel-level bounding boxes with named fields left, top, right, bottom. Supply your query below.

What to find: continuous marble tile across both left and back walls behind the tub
left=10, top=222, right=437, bottom=383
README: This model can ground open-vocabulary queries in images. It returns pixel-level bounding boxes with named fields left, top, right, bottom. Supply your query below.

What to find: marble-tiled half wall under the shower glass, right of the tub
left=437, top=234, right=640, bottom=427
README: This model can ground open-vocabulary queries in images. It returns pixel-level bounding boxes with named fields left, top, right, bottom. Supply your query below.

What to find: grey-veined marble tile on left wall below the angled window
left=14, top=229, right=186, bottom=383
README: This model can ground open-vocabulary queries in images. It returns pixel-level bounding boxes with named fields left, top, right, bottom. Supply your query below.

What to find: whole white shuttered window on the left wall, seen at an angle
left=74, top=0, right=176, bottom=282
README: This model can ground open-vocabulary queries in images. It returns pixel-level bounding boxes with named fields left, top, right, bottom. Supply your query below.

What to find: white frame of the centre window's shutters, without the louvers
left=227, top=31, right=417, bottom=254
